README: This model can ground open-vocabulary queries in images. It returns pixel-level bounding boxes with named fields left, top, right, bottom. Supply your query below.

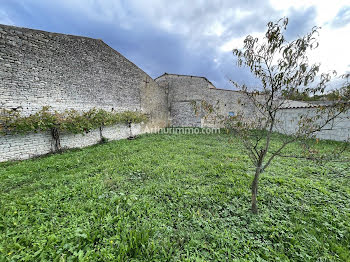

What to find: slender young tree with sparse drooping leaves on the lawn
left=225, top=18, right=349, bottom=213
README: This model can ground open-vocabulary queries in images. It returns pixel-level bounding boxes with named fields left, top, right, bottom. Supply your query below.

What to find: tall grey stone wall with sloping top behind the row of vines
left=0, top=25, right=168, bottom=161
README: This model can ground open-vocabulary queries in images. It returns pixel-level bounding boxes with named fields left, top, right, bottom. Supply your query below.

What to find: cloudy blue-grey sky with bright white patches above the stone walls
left=0, top=0, right=350, bottom=88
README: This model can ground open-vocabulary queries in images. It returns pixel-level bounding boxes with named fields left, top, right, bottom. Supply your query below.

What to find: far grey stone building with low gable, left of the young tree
left=155, top=73, right=253, bottom=127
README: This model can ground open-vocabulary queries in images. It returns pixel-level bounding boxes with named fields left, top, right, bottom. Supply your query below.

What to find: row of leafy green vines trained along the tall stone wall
left=0, top=107, right=147, bottom=162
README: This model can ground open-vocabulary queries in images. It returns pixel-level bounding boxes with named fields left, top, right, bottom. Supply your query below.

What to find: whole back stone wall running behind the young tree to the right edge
left=155, top=73, right=350, bottom=141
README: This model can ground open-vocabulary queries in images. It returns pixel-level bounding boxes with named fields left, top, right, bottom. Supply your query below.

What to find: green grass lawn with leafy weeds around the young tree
left=0, top=134, right=350, bottom=261
